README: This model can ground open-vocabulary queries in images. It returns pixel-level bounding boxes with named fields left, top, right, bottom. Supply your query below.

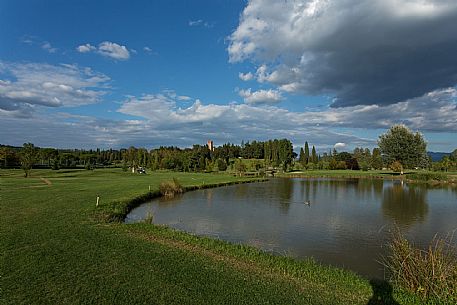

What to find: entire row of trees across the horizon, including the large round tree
left=0, top=125, right=457, bottom=174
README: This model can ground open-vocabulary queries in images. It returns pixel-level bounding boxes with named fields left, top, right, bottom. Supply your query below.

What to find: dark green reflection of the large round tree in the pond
left=382, top=182, right=428, bottom=227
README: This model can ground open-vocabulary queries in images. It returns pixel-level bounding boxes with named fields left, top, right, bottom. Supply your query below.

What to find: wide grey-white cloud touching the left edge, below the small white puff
left=0, top=62, right=109, bottom=116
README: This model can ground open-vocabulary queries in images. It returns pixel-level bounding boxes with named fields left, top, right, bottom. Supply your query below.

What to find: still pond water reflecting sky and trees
left=126, top=178, right=457, bottom=278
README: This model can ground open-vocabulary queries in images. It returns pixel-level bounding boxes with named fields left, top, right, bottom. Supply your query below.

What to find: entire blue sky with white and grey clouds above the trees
left=0, top=0, right=457, bottom=152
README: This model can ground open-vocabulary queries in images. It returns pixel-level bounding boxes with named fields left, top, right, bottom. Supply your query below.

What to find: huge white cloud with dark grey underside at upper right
left=228, top=0, right=457, bottom=107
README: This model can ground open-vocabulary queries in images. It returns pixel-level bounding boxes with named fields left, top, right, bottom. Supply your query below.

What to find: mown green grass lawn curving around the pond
left=0, top=169, right=421, bottom=305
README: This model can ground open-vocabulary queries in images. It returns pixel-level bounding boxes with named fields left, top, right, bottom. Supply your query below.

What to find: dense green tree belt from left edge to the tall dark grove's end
left=0, top=139, right=294, bottom=172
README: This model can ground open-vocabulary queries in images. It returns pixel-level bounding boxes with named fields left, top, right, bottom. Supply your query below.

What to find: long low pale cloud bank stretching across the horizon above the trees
left=0, top=86, right=457, bottom=151
